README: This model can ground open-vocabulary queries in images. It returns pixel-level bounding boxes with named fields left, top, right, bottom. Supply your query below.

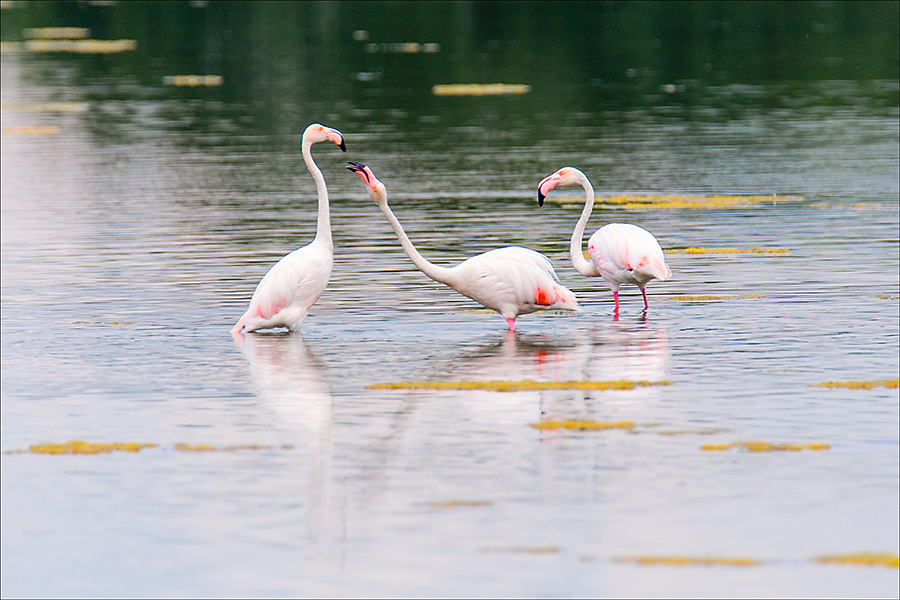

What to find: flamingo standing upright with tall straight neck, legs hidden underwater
left=231, top=123, right=347, bottom=337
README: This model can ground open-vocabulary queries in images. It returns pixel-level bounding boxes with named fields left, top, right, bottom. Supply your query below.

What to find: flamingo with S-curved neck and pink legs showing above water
left=538, top=167, right=672, bottom=317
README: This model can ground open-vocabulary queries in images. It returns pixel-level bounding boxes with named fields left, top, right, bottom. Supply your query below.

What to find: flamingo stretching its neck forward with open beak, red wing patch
left=347, top=162, right=581, bottom=331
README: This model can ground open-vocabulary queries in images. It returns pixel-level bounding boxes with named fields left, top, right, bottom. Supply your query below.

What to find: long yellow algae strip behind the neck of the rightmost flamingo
left=547, top=194, right=803, bottom=210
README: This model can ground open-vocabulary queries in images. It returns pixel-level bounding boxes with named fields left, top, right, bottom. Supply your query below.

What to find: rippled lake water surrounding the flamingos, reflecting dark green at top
left=0, top=2, right=900, bottom=597
